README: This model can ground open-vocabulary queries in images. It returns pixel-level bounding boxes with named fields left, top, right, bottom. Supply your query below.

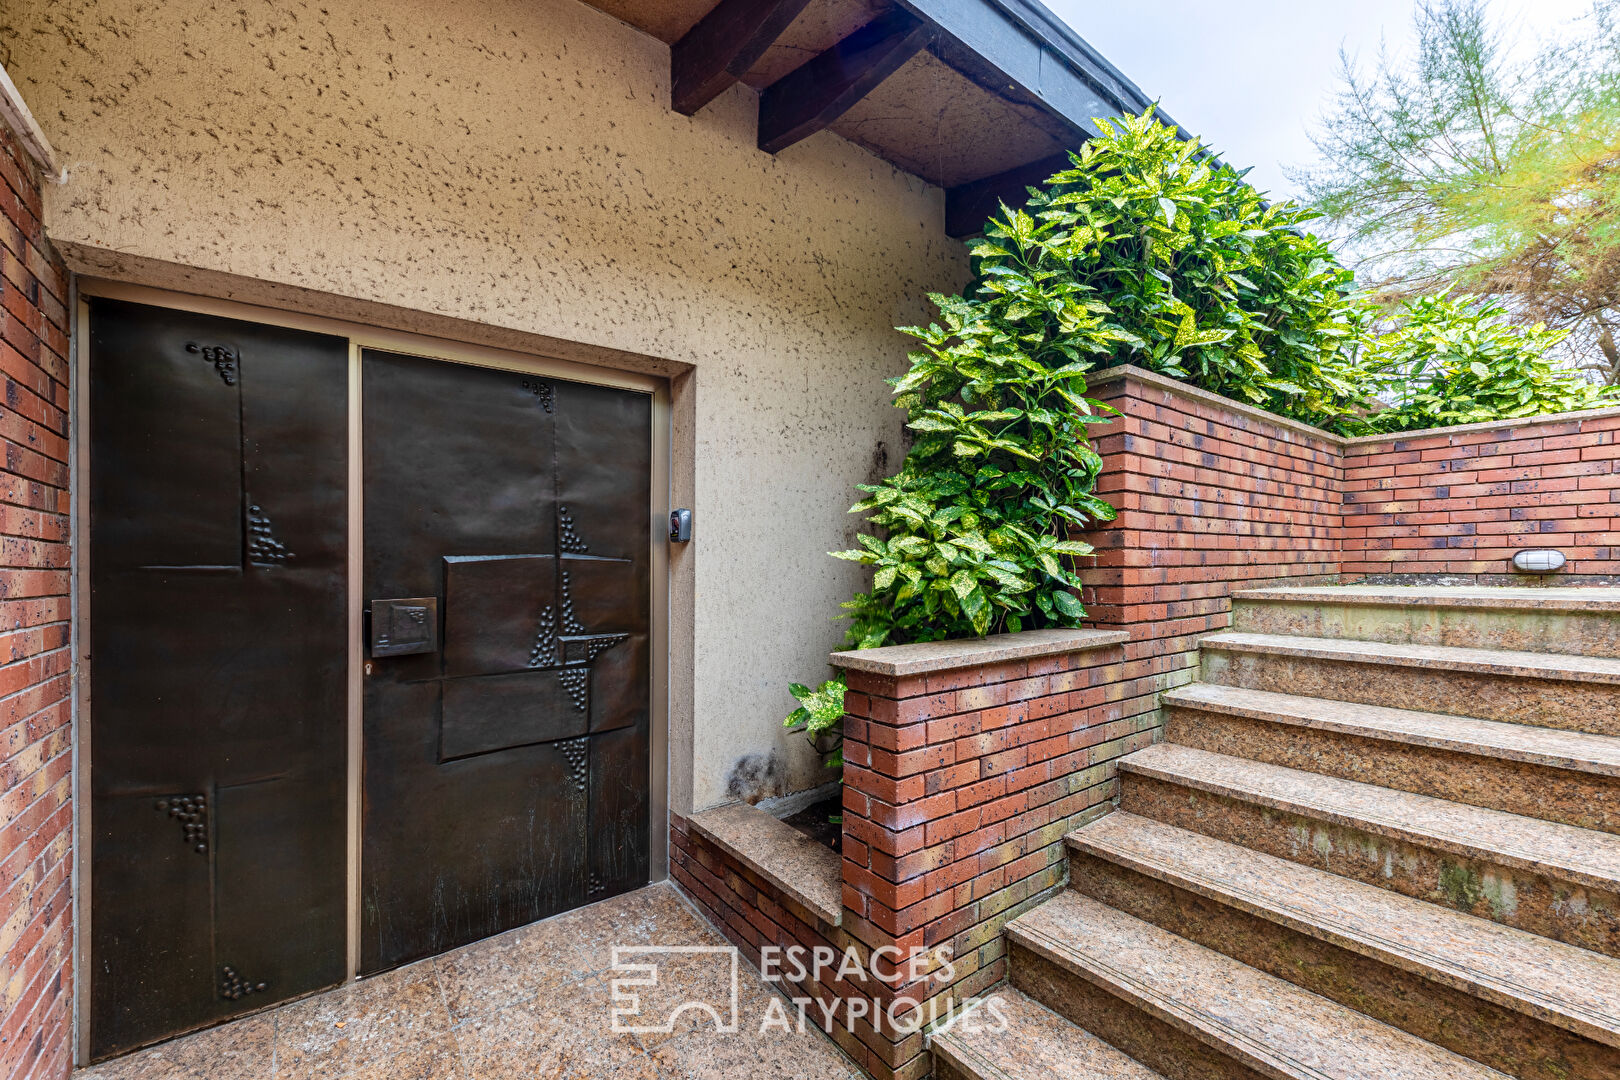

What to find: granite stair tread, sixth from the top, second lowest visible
left=1008, top=891, right=1505, bottom=1080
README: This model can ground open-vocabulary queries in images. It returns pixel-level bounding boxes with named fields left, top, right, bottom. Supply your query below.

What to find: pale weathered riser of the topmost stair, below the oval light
left=1231, top=601, right=1620, bottom=657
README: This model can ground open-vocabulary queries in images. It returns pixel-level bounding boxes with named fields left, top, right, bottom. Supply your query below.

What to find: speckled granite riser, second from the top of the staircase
left=1202, top=646, right=1620, bottom=735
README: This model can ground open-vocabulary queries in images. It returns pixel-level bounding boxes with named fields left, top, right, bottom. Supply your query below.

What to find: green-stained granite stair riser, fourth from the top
left=1119, top=772, right=1620, bottom=957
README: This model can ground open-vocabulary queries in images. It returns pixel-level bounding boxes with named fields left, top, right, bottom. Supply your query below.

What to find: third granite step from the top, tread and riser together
left=1160, top=683, right=1620, bottom=832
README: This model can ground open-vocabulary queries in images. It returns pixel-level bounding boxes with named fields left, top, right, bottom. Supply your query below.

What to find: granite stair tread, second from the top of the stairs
left=1199, top=630, right=1620, bottom=683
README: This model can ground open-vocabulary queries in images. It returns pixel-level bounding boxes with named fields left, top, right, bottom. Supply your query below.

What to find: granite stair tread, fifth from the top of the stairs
left=1068, top=811, right=1620, bottom=1046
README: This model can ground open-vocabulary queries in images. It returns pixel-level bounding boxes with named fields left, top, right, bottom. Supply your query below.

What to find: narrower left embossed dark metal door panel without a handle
left=86, top=300, right=348, bottom=1057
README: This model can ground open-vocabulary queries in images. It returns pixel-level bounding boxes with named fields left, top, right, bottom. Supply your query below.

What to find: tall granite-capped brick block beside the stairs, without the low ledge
left=831, top=630, right=1127, bottom=1080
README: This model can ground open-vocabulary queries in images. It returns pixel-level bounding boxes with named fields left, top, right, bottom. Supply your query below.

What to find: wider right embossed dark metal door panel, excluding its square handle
left=361, top=351, right=651, bottom=973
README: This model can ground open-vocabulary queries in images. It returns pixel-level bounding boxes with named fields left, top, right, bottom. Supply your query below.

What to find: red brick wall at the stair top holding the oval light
left=1341, top=410, right=1620, bottom=583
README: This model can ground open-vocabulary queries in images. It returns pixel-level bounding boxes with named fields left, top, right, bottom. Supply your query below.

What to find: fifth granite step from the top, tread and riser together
left=1066, top=813, right=1620, bottom=1080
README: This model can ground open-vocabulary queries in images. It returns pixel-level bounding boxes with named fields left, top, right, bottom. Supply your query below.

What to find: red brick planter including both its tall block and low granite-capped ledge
left=671, top=630, right=1127, bottom=1080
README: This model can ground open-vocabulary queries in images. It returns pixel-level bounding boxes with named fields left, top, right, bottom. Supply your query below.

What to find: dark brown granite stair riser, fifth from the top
left=1069, top=852, right=1620, bottom=1080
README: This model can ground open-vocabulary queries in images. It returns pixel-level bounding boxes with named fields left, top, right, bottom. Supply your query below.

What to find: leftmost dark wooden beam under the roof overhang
left=669, top=0, right=810, bottom=117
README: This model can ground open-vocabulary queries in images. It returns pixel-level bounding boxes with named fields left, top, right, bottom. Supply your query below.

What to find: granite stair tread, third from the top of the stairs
left=1162, top=683, right=1620, bottom=776
